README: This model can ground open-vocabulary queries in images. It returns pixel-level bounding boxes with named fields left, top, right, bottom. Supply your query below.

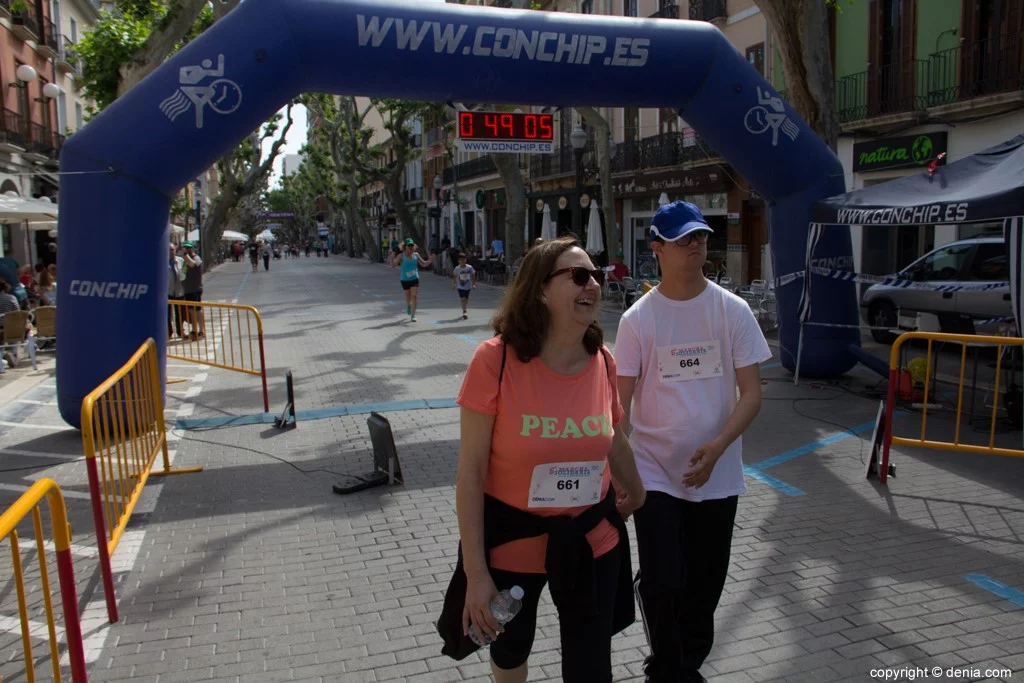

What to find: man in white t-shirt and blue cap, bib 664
left=615, top=202, right=771, bottom=683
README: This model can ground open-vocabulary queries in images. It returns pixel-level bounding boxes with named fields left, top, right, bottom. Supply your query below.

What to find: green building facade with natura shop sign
left=772, top=0, right=1024, bottom=274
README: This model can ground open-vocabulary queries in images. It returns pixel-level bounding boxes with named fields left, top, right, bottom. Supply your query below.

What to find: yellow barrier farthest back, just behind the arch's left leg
left=167, top=301, right=270, bottom=413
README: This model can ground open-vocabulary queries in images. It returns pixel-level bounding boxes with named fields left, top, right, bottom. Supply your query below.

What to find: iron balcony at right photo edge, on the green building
left=928, top=33, right=1024, bottom=106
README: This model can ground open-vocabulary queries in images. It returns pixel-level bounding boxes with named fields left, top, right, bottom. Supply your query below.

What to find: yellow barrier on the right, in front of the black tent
left=879, top=332, right=1024, bottom=483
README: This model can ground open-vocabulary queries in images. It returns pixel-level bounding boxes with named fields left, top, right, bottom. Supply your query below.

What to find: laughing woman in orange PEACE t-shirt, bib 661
left=438, top=238, right=644, bottom=683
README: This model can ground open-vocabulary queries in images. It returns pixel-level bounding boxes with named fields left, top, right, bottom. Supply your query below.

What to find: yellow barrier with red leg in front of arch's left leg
left=82, top=339, right=203, bottom=622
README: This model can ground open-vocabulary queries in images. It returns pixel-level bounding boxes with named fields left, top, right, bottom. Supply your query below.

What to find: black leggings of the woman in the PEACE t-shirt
left=490, top=544, right=629, bottom=683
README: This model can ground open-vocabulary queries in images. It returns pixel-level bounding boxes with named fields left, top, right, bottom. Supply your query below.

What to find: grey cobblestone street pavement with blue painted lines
left=0, top=256, right=1024, bottom=683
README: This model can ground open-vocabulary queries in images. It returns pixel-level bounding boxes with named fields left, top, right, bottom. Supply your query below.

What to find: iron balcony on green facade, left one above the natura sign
left=836, top=59, right=929, bottom=124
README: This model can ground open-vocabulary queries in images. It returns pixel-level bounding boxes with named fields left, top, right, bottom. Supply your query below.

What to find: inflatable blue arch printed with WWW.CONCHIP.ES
left=57, top=0, right=858, bottom=427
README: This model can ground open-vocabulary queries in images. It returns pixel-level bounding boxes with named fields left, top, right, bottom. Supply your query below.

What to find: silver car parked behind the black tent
left=860, top=238, right=1013, bottom=342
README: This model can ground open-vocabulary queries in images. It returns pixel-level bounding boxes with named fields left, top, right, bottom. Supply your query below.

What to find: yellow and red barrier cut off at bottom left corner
left=0, top=479, right=88, bottom=683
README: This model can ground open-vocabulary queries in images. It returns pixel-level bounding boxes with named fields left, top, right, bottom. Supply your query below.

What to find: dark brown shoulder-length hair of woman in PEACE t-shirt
left=490, top=237, right=604, bottom=362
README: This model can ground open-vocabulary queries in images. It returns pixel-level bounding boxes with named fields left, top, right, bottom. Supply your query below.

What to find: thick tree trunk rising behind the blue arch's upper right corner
left=755, top=0, right=839, bottom=150
